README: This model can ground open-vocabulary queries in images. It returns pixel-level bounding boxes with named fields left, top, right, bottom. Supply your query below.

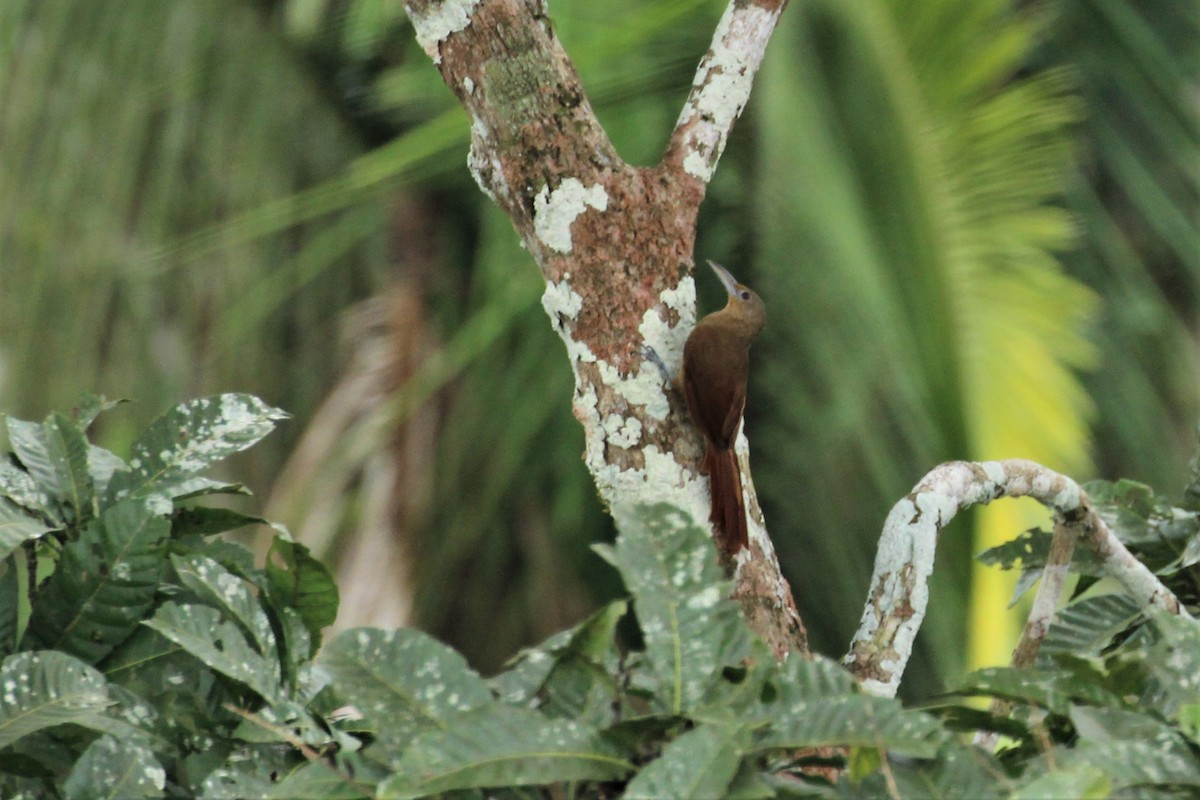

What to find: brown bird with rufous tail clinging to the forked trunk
left=678, top=261, right=767, bottom=555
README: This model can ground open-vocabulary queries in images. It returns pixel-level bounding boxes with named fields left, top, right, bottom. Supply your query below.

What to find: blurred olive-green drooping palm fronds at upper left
left=0, top=0, right=384, bottom=458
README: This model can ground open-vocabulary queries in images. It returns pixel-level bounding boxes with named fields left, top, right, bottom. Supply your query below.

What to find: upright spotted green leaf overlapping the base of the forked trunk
left=606, top=504, right=750, bottom=714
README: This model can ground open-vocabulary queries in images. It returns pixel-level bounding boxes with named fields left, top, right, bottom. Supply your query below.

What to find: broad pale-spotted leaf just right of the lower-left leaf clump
left=317, top=627, right=492, bottom=762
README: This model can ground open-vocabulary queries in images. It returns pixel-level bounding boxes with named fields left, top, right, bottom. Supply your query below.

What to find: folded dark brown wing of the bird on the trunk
left=683, top=325, right=750, bottom=450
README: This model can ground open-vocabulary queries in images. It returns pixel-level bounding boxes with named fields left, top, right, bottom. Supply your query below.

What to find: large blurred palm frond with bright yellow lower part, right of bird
left=750, top=1, right=1094, bottom=692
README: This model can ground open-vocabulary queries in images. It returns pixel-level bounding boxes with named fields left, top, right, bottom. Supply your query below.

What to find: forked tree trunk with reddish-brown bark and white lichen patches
left=406, top=0, right=808, bottom=656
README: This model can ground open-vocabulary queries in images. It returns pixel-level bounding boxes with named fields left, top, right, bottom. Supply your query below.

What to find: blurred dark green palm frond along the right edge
left=1042, top=0, right=1200, bottom=489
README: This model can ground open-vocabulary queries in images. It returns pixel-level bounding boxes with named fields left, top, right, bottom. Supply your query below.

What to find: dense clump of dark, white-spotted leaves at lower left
left=0, top=395, right=337, bottom=798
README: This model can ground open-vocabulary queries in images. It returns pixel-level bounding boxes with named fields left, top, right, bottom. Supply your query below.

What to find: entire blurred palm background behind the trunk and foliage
left=0, top=0, right=1200, bottom=693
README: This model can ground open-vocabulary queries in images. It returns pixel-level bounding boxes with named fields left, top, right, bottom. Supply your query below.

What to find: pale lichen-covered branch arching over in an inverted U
left=844, top=459, right=1187, bottom=697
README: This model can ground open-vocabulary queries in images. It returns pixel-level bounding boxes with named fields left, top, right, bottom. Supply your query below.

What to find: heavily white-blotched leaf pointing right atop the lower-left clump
left=109, top=393, right=287, bottom=498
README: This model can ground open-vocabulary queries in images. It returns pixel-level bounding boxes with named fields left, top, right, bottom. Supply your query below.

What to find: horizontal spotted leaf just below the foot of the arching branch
left=755, top=694, right=949, bottom=758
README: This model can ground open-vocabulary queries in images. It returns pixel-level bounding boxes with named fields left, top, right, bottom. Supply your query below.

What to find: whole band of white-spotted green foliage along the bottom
left=7, top=395, right=1200, bottom=800
